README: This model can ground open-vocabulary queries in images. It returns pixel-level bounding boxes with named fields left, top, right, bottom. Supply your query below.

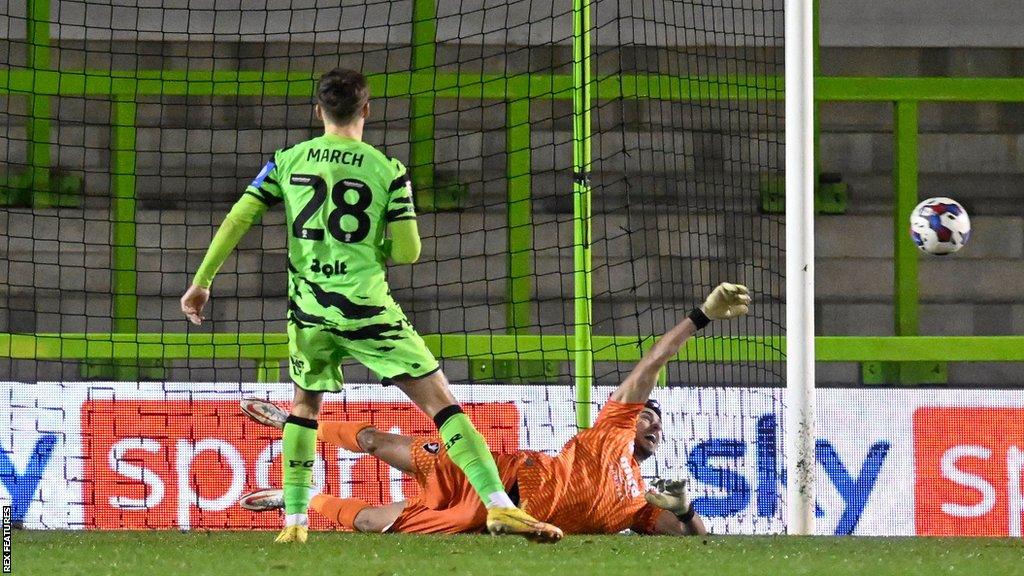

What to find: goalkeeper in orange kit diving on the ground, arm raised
left=241, top=284, right=751, bottom=535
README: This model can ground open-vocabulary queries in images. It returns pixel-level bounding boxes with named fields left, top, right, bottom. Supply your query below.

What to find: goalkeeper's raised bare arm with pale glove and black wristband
left=611, top=282, right=751, bottom=404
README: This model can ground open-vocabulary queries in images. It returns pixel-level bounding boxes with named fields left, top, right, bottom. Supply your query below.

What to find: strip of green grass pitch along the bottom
left=13, top=531, right=1024, bottom=576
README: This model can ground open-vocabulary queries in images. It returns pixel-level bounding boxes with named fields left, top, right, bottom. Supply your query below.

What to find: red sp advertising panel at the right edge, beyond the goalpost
left=913, top=408, right=1024, bottom=536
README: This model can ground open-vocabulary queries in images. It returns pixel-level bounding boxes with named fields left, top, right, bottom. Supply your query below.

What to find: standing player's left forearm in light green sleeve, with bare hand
left=181, top=194, right=267, bottom=325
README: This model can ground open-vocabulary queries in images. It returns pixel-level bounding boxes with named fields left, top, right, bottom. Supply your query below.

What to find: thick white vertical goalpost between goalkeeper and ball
left=785, top=0, right=815, bottom=534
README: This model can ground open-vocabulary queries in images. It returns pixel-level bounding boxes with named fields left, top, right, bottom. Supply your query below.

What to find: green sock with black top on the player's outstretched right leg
left=434, top=404, right=515, bottom=508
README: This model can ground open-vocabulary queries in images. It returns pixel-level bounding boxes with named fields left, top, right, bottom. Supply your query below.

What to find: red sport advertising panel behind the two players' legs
left=82, top=400, right=519, bottom=529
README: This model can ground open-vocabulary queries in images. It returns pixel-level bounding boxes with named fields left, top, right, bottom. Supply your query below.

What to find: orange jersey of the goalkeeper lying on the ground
left=518, top=401, right=660, bottom=534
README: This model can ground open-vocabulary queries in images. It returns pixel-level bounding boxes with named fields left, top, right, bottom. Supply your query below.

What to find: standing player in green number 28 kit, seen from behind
left=181, top=69, right=562, bottom=542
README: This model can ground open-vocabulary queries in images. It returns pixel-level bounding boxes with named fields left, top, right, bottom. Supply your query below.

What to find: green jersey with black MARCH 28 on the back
left=246, top=134, right=416, bottom=325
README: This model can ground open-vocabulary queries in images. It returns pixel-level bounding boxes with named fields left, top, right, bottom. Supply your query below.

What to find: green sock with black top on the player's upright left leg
left=281, top=416, right=316, bottom=518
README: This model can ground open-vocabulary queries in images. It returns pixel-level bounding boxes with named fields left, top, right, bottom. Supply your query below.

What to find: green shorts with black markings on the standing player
left=288, top=306, right=440, bottom=392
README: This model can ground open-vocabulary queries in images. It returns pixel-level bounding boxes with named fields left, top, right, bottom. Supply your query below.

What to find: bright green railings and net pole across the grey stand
left=0, top=0, right=1024, bottom=389
